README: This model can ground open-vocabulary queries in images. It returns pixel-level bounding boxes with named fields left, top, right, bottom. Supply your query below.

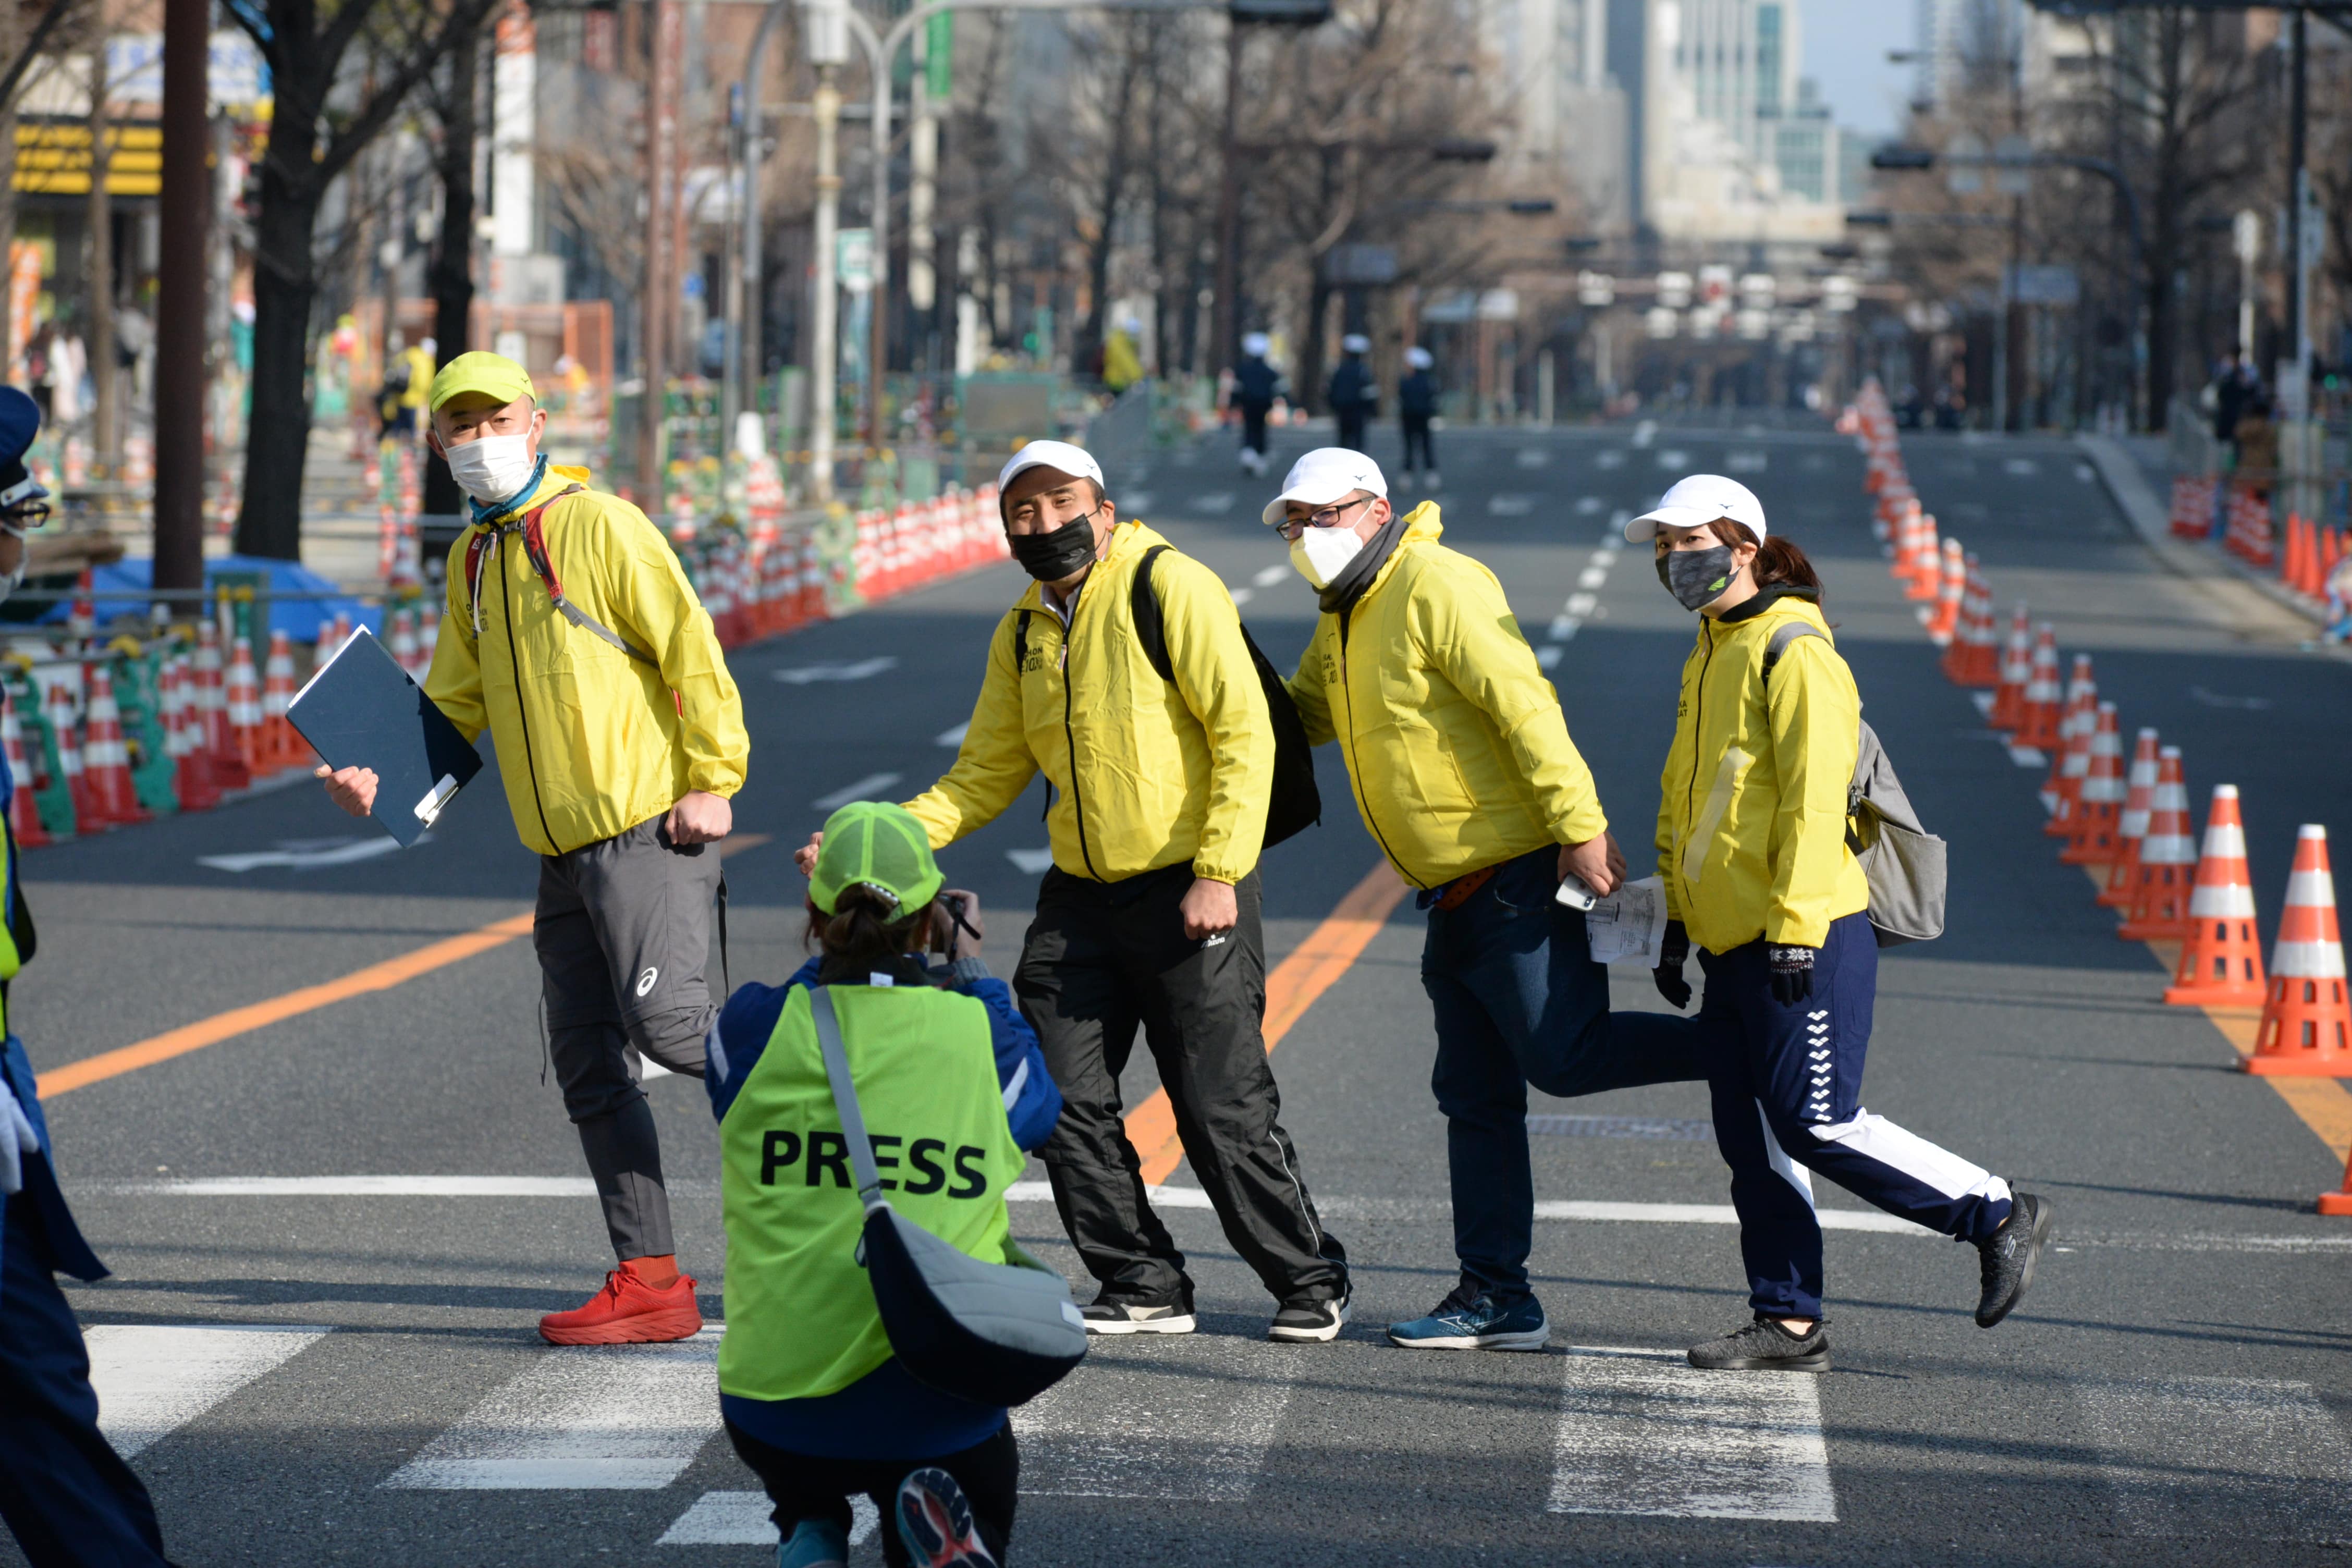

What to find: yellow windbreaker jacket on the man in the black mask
left=905, top=522, right=1275, bottom=881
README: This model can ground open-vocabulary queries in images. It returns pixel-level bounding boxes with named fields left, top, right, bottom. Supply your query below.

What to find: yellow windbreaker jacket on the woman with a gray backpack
left=1658, top=597, right=1870, bottom=952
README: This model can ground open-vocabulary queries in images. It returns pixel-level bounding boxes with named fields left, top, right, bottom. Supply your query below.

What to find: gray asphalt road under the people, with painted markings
left=0, top=421, right=2352, bottom=1568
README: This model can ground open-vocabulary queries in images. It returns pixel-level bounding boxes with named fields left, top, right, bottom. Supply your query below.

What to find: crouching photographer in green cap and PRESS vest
left=703, top=802, right=1061, bottom=1568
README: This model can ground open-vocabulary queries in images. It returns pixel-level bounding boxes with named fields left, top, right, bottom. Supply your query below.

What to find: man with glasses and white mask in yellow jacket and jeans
left=1265, top=447, right=1705, bottom=1350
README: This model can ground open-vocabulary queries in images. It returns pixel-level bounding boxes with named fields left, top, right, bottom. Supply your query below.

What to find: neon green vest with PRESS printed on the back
left=720, top=985, right=1028, bottom=1399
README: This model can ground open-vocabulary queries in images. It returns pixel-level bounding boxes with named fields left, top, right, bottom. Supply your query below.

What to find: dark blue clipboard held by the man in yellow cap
left=287, top=626, right=482, bottom=849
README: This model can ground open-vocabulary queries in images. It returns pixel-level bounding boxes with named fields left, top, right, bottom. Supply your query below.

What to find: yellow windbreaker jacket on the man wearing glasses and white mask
left=1291, top=501, right=1609, bottom=889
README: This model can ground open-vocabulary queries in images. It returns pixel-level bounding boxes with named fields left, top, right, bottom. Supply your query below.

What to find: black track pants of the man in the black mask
left=1014, top=865, right=1348, bottom=1305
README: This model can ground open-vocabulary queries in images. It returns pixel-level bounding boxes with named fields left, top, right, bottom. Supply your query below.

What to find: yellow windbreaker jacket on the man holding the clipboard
left=426, top=463, right=750, bottom=856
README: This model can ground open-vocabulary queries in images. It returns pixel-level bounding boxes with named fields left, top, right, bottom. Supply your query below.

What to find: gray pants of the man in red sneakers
left=532, top=816, right=720, bottom=1260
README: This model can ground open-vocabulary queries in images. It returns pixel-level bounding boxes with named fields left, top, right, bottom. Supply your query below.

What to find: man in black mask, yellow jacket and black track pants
left=802, top=442, right=1348, bottom=1342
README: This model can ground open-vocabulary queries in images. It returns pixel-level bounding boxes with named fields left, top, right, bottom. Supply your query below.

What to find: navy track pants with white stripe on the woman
left=1698, top=914, right=2008, bottom=1319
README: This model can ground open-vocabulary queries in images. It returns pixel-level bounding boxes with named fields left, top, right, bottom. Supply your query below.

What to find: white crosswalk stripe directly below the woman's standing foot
left=1550, top=1347, right=1837, bottom=1523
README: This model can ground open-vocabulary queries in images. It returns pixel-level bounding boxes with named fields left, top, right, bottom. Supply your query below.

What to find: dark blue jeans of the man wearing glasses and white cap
left=1420, top=847, right=1708, bottom=1302
